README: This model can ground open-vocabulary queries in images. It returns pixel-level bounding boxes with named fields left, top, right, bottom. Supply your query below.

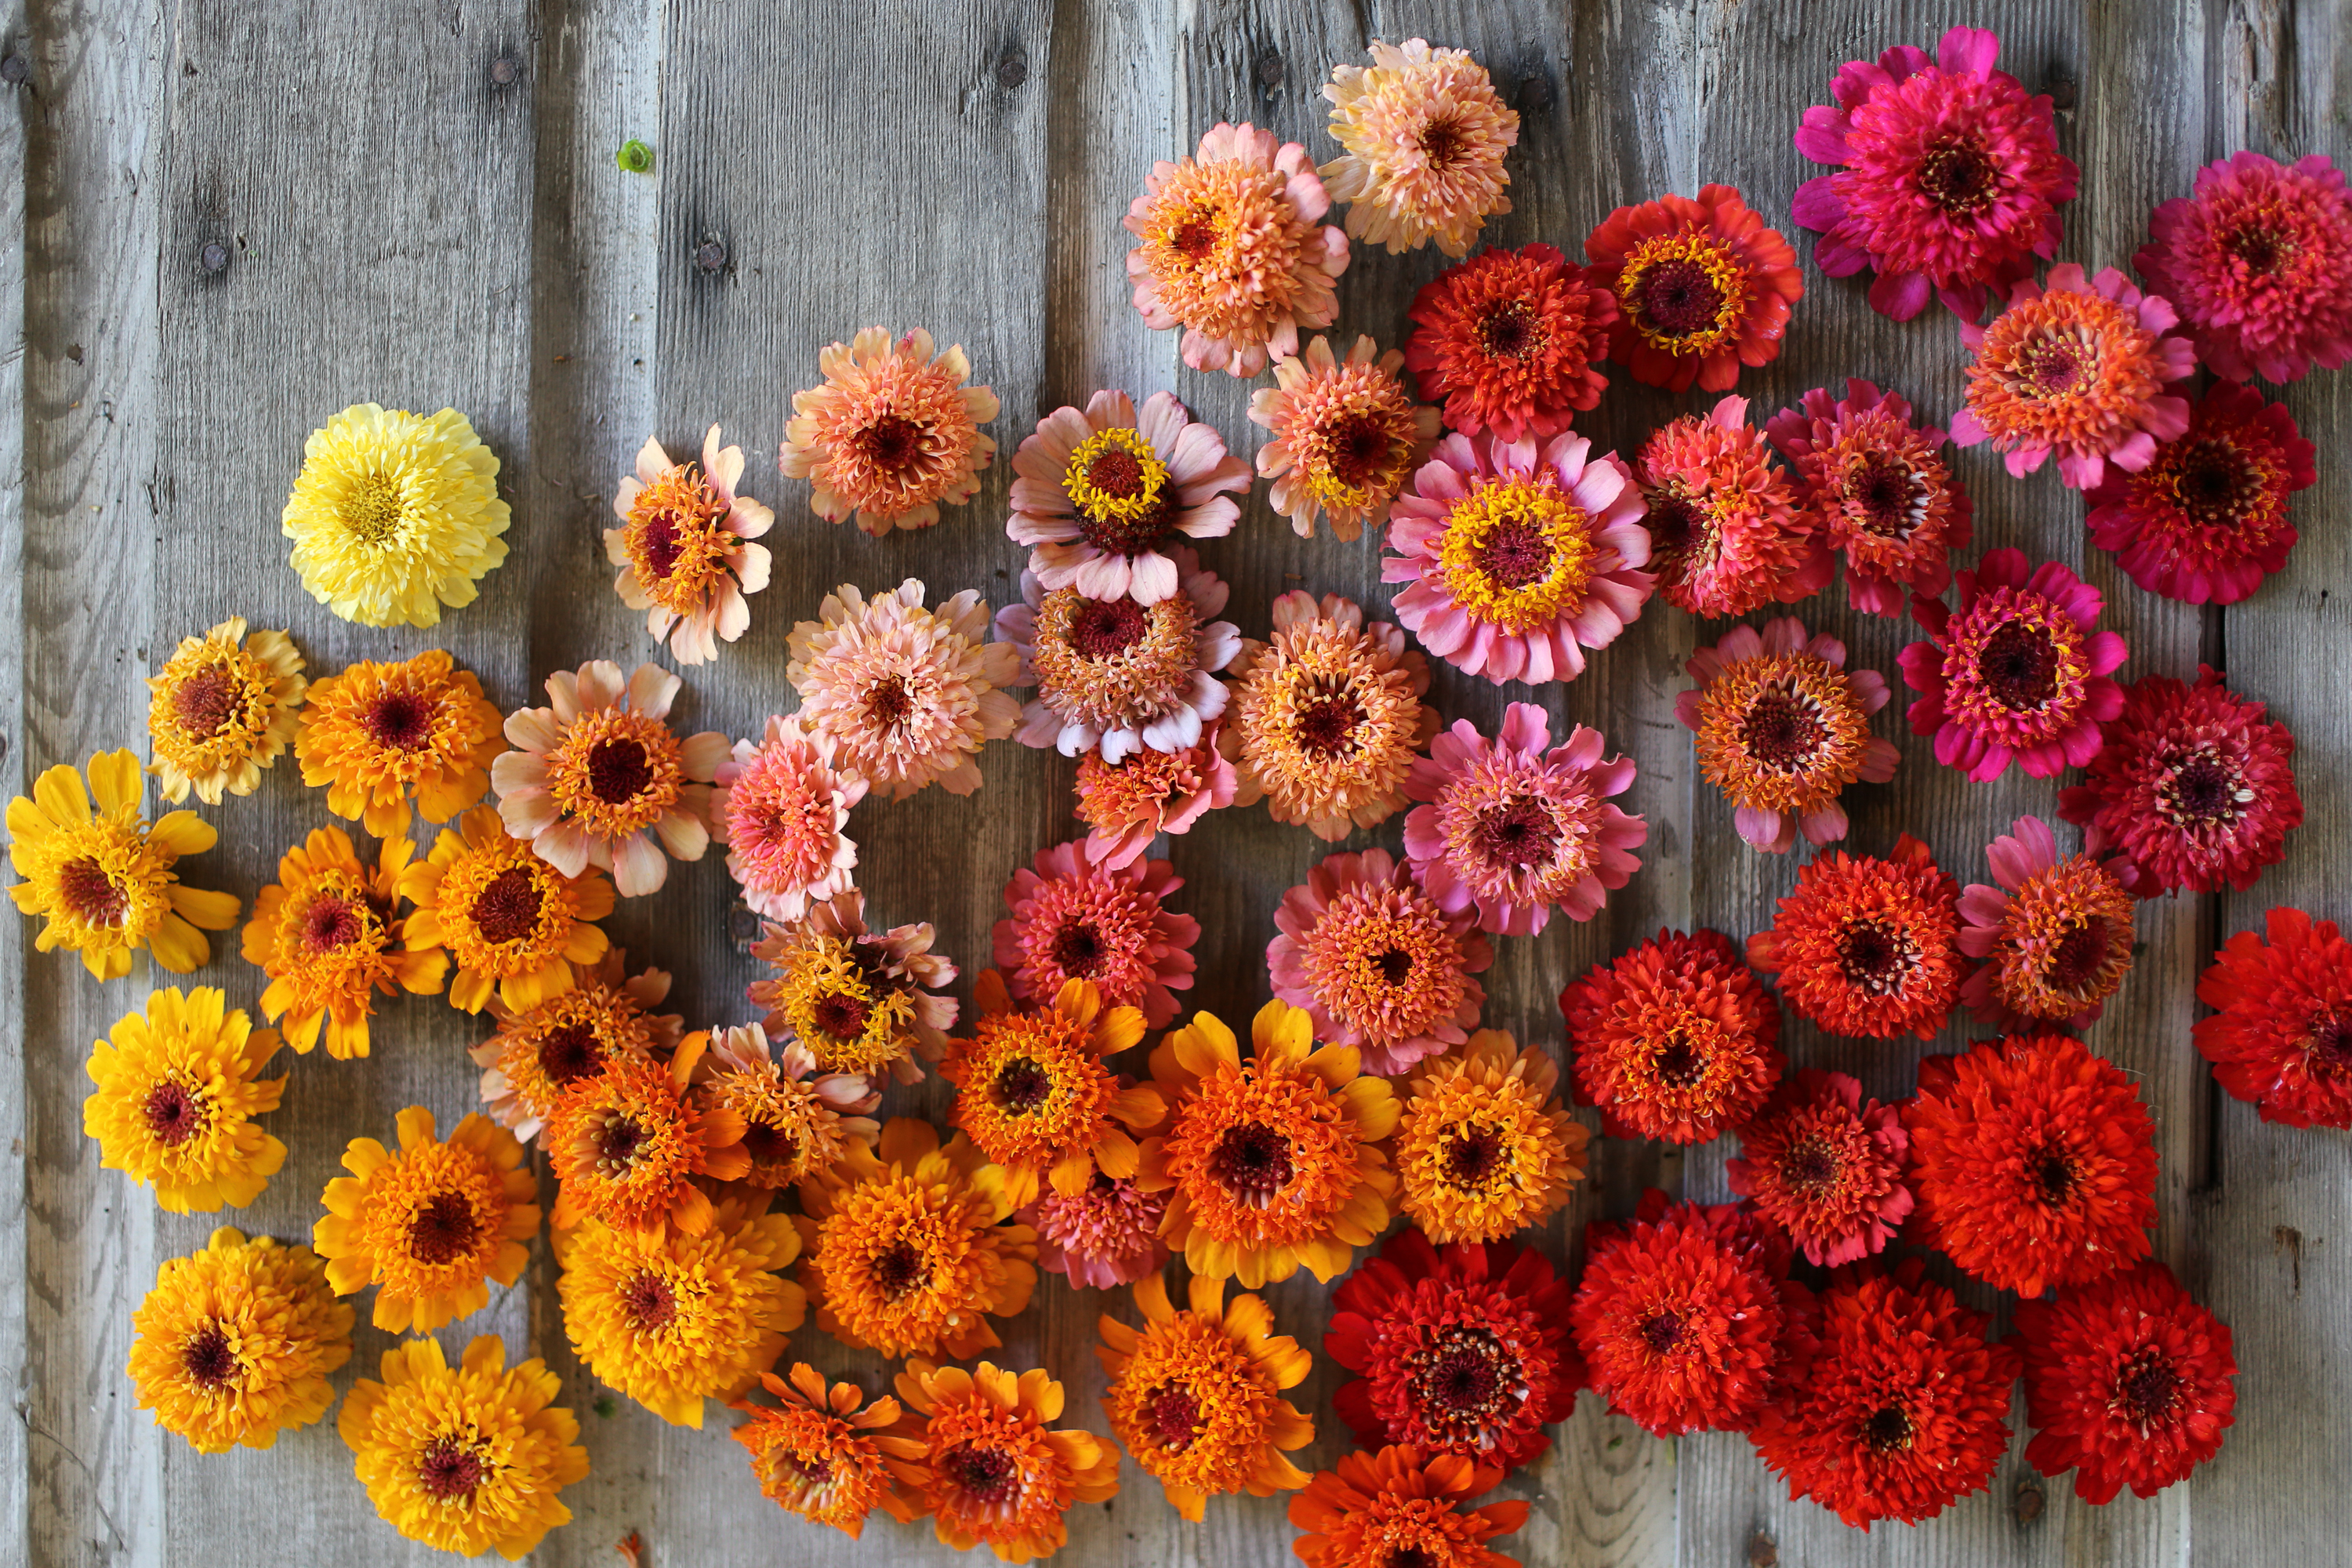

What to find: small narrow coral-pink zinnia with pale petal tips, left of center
left=710, top=715, right=866, bottom=919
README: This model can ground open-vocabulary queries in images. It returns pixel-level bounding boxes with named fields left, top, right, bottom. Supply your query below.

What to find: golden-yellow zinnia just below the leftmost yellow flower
left=82, top=992, right=287, bottom=1213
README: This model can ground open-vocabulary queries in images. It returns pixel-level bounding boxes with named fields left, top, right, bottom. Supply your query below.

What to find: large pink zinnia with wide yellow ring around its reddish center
left=1381, top=435, right=1656, bottom=687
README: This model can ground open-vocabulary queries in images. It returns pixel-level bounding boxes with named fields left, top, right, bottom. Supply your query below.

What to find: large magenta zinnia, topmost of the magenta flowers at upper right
left=1790, top=28, right=2082, bottom=319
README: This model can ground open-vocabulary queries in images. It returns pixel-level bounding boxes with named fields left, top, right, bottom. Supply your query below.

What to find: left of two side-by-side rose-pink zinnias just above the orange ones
left=993, top=839, right=1200, bottom=1029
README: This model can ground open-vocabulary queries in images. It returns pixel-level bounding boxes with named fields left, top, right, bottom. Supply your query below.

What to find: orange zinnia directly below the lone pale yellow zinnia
left=294, top=649, right=503, bottom=839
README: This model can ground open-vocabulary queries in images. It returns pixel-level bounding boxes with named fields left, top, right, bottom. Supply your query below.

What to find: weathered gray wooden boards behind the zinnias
left=0, top=0, right=2352, bottom=1568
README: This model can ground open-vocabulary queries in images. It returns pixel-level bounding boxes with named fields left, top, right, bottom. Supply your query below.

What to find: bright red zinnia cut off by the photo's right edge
left=2197, top=909, right=2352, bottom=1126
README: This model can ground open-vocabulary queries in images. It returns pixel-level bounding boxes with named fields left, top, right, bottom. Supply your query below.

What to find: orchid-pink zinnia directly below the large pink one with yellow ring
left=1404, top=703, right=1649, bottom=935
